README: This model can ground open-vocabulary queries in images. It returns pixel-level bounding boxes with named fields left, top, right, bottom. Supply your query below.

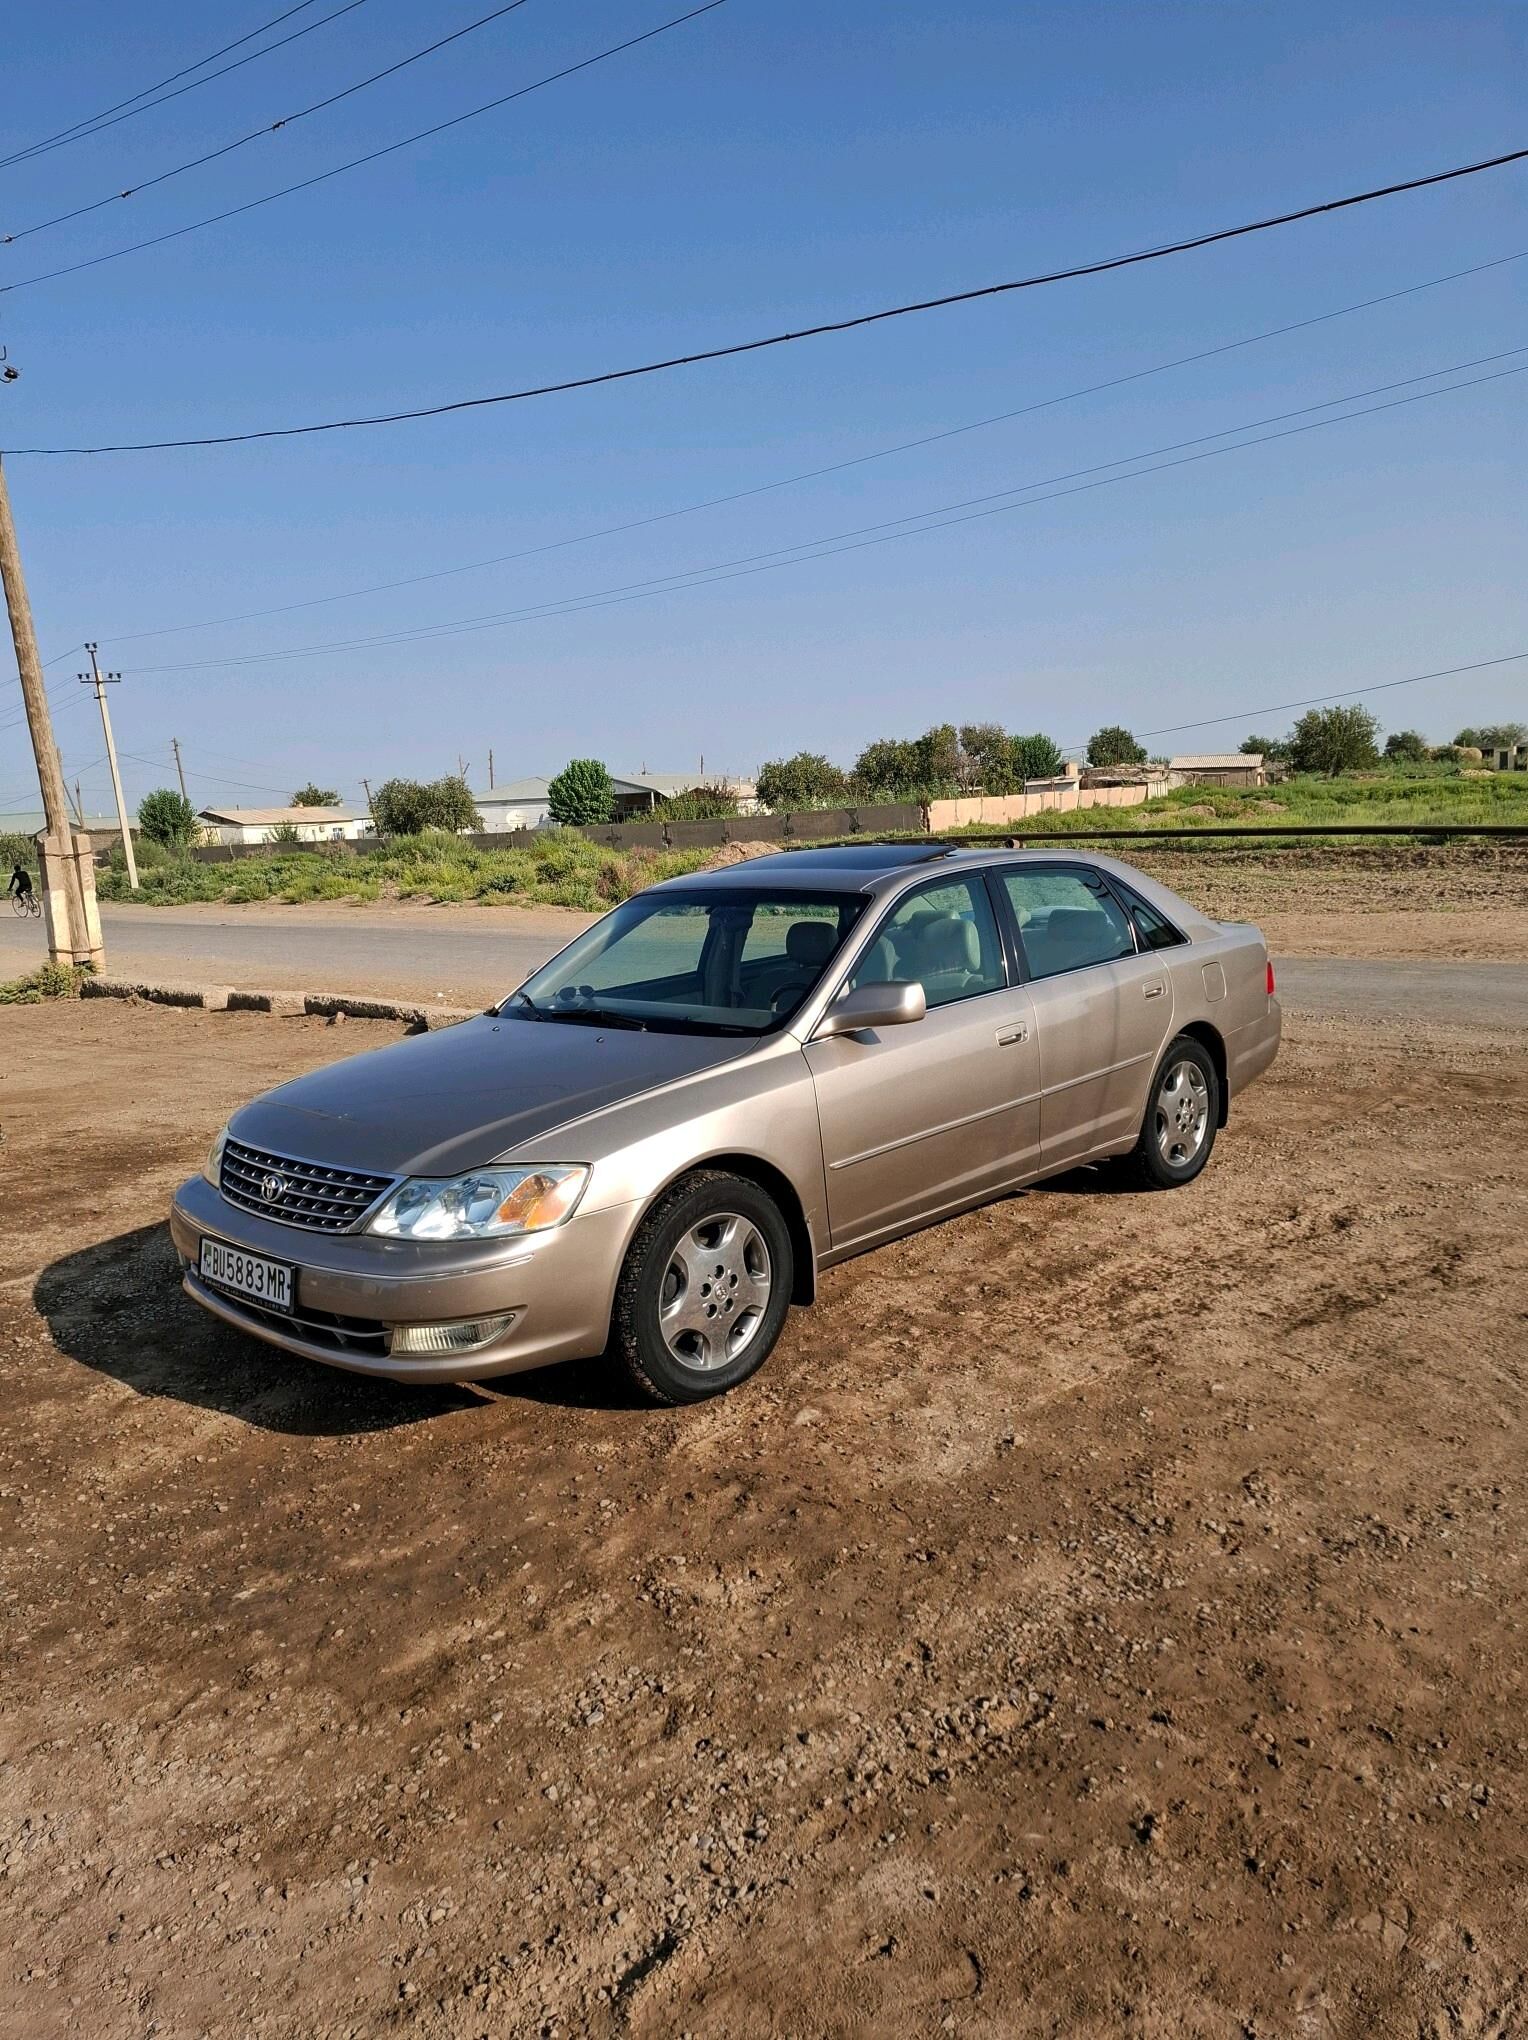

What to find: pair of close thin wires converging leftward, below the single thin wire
left=122, top=349, right=1528, bottom=673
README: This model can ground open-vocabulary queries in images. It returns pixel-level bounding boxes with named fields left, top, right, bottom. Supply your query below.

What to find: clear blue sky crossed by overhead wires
left=0, top=0, right=1528, bottom=808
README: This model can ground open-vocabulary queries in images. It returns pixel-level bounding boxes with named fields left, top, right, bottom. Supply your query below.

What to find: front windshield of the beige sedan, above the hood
left=502, top=885, right=865, bottom=1034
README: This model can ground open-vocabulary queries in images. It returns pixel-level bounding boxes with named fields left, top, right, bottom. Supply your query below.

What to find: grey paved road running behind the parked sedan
left=0, top=906, right=1528, bottom=1028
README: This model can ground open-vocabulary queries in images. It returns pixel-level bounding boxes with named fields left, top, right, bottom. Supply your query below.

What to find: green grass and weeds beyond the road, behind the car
left=98, top=773, right=1528, bottom=912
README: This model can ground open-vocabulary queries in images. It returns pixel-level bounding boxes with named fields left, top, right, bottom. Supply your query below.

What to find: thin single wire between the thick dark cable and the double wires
left=74, top=249, right=1528, bottom=657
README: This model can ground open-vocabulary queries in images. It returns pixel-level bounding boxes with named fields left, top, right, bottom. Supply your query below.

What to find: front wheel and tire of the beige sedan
left=610, top=1169, right=796, bottom=1404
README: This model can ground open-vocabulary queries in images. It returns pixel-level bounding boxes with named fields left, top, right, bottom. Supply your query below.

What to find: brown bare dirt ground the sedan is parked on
left=0, top=1002, right=1528, bottom=2040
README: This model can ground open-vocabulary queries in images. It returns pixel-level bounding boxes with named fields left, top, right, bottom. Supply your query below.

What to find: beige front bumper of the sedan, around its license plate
left=169, top=1177, right=636, bottom=1381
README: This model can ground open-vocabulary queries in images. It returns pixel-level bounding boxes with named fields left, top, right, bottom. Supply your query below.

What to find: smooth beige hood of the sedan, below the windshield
left=231, top=1014, right=757, bottom=1175
